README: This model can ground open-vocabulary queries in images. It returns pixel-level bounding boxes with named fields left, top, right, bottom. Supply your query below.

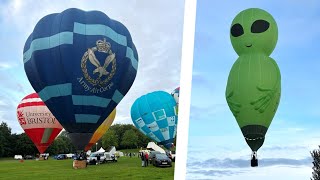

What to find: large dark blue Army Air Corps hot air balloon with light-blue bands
left=23, top=8, right=138, bottom=150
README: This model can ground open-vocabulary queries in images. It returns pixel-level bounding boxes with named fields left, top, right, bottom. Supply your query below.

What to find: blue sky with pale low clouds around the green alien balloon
left=187, top=0, right=320, bottom=180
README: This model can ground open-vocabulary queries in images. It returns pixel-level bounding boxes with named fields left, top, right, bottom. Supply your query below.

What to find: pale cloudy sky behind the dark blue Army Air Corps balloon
left=0, top=0, right=184, bottom=133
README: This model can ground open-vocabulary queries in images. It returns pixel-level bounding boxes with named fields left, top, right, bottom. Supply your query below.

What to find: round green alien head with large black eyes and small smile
left=230, top=8, right=278, bottom=56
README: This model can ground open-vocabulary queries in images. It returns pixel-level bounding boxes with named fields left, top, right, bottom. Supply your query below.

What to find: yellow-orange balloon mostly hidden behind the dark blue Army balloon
left=84, top=109, right=116, bottom=151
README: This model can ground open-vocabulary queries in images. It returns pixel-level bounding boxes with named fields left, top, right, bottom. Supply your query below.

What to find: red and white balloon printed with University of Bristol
left=17, top=93, right=63, bottom=154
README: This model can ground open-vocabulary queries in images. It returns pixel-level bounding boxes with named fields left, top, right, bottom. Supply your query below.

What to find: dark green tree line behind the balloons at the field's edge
left=0, top=122, right=161, bottom=158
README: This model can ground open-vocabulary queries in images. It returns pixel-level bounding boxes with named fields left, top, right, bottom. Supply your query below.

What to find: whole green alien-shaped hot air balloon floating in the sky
left=226, top=8, right=281, bottom=166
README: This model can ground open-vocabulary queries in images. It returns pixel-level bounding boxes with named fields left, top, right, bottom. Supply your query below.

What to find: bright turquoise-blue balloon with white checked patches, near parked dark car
left=131, top=91, right=178, bottom=148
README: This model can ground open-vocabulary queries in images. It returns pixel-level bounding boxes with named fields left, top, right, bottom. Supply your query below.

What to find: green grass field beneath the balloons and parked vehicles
left=0, top=156, right=174, bottom=180
